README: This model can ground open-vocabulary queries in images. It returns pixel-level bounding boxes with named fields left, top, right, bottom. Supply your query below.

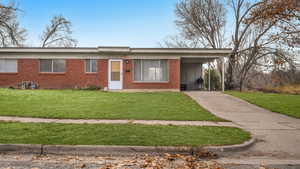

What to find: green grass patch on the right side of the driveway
left=226, top=91, right=300, bottom=118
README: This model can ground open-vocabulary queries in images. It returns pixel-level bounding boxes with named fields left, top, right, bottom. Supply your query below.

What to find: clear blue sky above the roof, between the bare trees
left=16, top=0, right=178, bottom=47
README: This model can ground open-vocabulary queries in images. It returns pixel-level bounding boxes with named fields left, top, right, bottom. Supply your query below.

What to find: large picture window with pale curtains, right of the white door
left=134, top=60, right=168, bottom=82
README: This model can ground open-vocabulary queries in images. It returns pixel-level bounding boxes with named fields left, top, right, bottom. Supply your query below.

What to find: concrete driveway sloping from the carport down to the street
left=186, top=92, right=300, bottom=159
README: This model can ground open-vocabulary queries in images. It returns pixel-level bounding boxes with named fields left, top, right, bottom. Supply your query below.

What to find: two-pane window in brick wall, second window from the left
left=40, top=59, right=66, bottom=72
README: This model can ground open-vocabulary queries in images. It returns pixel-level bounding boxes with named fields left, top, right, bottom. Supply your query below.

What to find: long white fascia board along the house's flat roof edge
left=0, top=47, right=231, bottom=59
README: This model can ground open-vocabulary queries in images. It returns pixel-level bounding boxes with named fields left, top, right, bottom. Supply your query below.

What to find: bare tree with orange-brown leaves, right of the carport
left=227, top=0, right=299, bottom=90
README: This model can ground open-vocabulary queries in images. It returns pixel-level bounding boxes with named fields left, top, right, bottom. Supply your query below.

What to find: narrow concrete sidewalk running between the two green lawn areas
left=0, top=116, right=239, bottom=127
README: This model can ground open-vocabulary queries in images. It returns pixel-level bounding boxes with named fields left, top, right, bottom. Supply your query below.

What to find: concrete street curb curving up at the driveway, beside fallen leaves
left=0, top=136, right=256, bottom=155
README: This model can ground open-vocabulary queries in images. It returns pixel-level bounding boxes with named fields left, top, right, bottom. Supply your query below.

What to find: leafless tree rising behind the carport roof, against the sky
left=165, top=0, right=226, bottom=48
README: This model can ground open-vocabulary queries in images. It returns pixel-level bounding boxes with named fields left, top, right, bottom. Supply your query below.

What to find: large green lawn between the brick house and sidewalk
left=0, top=89, right=224, bottom=121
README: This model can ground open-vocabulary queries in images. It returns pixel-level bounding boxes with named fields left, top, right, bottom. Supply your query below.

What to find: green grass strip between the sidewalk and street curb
left=0, top=122, right=250, bottom=146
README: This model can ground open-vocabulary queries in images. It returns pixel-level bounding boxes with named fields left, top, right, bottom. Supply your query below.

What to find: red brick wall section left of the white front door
left=0, top=59, right=108, bottom=88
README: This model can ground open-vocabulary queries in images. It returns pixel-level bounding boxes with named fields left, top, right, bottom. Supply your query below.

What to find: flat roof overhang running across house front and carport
left=0, top=46, right=232, bottom=58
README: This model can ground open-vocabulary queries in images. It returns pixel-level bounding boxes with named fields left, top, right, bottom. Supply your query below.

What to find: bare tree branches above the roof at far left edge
left=0, top=1, right=26, bottom=47
